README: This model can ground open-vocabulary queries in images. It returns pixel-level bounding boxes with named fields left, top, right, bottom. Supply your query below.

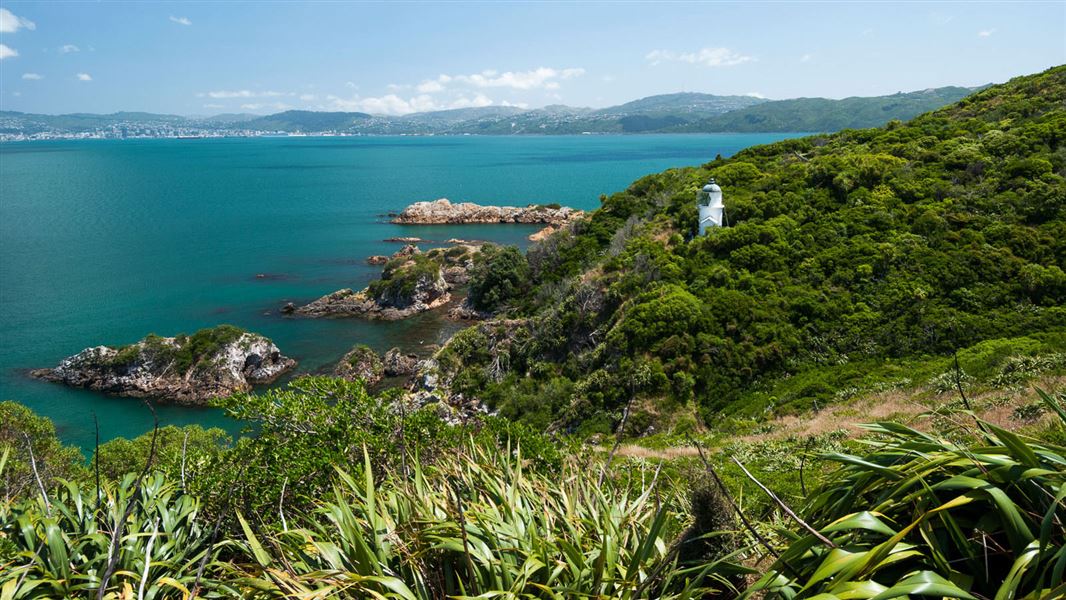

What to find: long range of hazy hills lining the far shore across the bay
left=0, top=87, right=974, bottom=136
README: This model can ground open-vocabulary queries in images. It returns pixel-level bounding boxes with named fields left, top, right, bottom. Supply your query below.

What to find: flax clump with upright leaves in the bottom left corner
left=0, top=461, right=229, bottom=600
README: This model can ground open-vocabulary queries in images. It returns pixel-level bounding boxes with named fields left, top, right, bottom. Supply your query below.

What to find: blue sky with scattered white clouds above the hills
left=0, top=0, right=1066, bottom=115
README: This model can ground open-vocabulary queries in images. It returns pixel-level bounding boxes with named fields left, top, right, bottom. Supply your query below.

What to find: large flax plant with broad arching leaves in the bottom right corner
left=748, top=391, right=1066, bottom=600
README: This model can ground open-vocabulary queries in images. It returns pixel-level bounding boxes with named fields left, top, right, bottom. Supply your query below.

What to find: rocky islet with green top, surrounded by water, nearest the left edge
left=30, top=325, right=296, bottom=404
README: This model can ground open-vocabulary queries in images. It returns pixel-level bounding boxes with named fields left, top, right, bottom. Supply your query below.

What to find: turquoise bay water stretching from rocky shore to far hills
left=0, top=134, right=801, bottom=448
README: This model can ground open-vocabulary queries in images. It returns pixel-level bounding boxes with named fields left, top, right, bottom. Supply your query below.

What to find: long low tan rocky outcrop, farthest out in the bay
left=392, top=198, right=583, bottom=226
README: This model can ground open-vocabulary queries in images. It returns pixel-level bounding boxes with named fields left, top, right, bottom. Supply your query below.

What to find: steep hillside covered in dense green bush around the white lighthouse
left=440, top=67, right=1066, bottom=435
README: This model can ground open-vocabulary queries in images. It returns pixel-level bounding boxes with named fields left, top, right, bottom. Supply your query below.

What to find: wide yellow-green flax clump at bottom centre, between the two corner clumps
left=231, top=447, right=743, bottom=599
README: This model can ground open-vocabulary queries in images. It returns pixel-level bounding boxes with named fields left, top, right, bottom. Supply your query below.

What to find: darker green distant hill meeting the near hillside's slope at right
left=675, top=87, right=979, bottom=132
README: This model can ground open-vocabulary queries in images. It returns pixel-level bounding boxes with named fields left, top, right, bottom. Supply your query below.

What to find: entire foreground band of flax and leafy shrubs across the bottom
left=0, top=387, right=1066, bottom=600
